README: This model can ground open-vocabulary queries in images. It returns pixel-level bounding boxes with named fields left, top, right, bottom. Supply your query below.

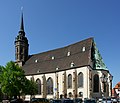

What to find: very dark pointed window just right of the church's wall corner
left=93, top=74, right=99, bottom=92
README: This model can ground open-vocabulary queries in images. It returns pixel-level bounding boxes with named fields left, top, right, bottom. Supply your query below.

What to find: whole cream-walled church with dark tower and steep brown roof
left=15, top=14, right=112, bottom=99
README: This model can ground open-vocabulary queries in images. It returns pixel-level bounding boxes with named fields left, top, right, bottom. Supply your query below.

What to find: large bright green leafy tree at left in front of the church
left=0, top=61, right=35, bottom=98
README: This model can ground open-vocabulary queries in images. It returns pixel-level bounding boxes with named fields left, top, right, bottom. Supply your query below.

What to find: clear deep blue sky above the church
left=0, top=0, right=120, bottom=86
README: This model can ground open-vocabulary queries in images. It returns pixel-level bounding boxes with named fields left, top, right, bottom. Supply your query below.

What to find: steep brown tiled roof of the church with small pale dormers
left=22, top=38, right=93, bottom=75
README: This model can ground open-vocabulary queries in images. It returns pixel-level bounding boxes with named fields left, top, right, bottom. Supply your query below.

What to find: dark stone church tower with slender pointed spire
left=15, top=13, right=29, bottom=66
